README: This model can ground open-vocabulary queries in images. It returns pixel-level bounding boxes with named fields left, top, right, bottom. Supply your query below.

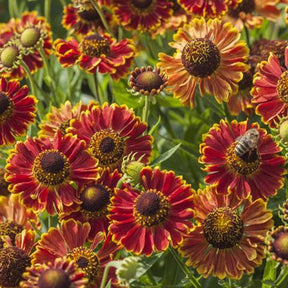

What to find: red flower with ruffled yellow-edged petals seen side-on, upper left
left=54, top=34, right=135, bottom=80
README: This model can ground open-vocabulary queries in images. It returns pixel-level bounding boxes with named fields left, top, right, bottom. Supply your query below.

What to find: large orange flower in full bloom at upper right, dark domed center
left=158, top=18, right=248, bottom=108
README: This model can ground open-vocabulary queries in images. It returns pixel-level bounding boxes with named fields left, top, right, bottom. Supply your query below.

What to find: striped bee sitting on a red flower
left=234, top=128, right=260, bottom=157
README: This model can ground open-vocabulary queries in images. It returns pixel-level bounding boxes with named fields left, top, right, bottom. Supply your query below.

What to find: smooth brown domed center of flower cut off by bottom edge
left=38, top=268, right=71, bottom=288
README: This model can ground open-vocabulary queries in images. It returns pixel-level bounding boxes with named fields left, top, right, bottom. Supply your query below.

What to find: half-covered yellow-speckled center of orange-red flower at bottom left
left=66, top=246, right=99, bottom=282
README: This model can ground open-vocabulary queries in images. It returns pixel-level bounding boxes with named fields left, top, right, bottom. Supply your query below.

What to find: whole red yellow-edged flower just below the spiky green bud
left=109, top=167, right=194, bottom=255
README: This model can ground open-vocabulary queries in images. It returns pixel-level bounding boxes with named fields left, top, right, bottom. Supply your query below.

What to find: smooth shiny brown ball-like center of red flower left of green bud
left=80, top=184, right=110, bottom=216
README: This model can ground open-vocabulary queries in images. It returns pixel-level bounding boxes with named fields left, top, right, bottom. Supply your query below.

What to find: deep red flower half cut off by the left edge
left=0, top=78, right=37, bottom=145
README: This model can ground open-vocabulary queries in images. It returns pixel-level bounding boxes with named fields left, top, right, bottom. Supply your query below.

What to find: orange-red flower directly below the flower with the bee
left=179, top=186, right=273, bottom=279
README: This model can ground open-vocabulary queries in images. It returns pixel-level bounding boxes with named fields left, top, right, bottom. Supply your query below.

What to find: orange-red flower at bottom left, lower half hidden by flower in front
left=32, top=219, right=120, bottom=288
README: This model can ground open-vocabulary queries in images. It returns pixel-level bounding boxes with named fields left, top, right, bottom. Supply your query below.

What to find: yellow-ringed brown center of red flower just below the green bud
left=134, top=190, right=170, bottom=227
